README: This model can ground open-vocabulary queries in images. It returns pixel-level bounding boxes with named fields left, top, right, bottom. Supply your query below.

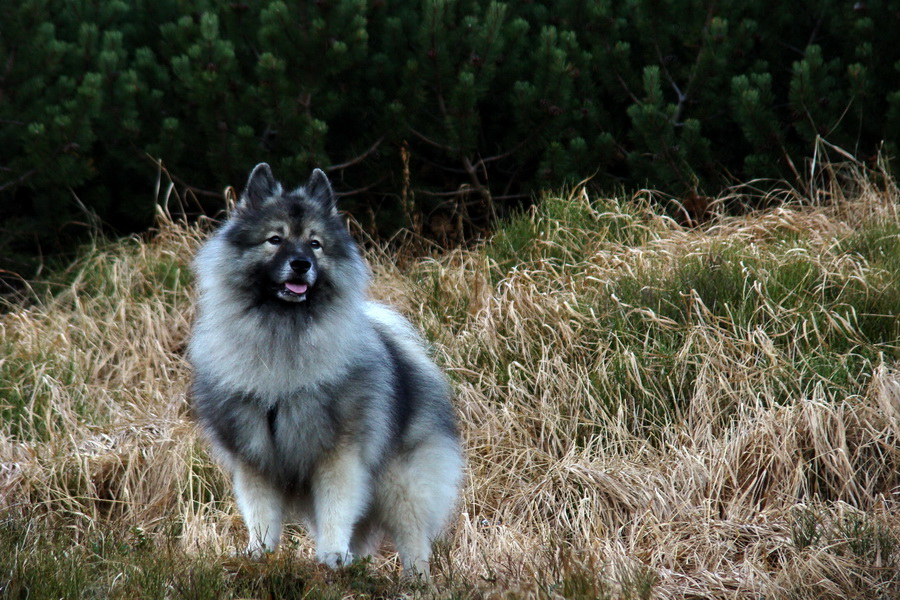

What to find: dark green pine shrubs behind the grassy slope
left=0, top=0, right=900, bottom=278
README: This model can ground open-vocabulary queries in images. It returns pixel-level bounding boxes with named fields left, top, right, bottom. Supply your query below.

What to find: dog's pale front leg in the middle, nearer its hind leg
left=313, top=447, right=370, bottom=568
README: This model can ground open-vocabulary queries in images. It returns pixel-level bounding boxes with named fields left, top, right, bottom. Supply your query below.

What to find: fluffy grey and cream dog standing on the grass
left=189, top=164, right=463, bottom=576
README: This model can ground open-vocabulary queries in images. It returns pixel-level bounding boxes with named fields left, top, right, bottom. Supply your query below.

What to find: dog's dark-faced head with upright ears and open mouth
left=224, top=163, right=364, bottom=304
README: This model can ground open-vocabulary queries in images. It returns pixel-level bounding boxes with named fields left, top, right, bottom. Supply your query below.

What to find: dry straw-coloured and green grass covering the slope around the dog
left=0, top=165, right=900, bottom=600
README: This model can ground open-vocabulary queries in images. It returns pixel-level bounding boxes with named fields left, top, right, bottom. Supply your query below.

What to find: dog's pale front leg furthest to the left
left=233, top=462, right=284, bottom=557
